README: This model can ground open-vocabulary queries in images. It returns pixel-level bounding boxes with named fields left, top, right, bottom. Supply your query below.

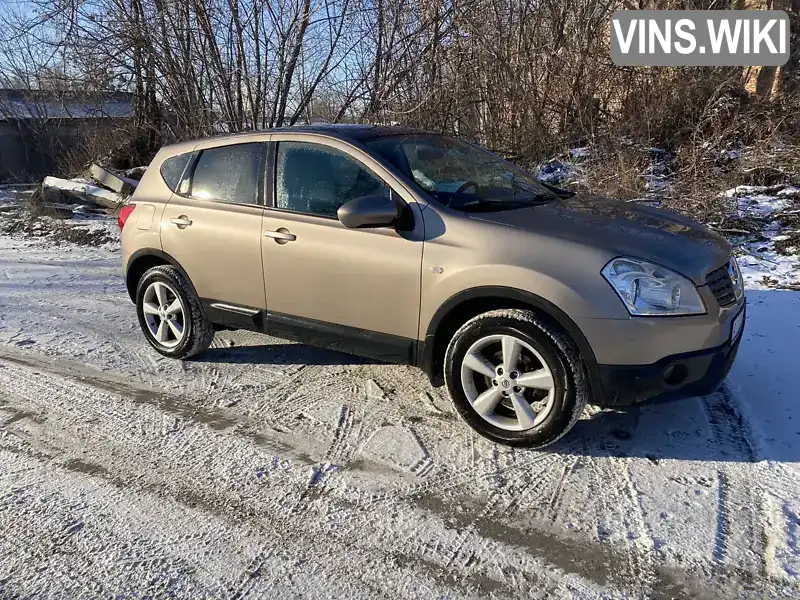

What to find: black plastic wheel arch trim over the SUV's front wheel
left=417, top=286, right=602, bottom=397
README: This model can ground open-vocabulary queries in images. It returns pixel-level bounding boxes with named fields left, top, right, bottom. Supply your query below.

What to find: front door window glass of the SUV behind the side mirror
left=275, top=142, right=390, bottom=218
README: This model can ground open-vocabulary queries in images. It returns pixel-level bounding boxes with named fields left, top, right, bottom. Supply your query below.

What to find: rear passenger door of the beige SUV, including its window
left=161, top=142, right=266, bottom=326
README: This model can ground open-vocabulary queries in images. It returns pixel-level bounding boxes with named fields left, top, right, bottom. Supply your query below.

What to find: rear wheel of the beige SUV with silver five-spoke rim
left=136, top=265, right=214, bottom=359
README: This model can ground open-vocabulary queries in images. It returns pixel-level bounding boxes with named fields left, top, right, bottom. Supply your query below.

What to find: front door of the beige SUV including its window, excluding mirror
left=262, top=141, right=423, bottom=362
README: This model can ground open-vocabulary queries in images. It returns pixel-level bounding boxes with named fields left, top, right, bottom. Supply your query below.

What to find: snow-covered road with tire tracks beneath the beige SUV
left=0, top=237, right=800, bottom=599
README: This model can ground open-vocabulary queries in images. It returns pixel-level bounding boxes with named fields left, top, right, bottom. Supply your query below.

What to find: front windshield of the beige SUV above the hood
left=366, top=134, right=558, bottom=211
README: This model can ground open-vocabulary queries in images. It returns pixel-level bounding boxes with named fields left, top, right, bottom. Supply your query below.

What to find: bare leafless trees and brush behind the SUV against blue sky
left=0, top=0, right=797, bottom=170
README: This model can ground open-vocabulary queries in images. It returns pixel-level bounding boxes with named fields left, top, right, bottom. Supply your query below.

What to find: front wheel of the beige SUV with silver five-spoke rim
left=444, top=309, right=591, bottom=448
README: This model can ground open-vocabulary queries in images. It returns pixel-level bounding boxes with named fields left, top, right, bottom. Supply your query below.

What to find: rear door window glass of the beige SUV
left=189, top=143, right=262, bottom=204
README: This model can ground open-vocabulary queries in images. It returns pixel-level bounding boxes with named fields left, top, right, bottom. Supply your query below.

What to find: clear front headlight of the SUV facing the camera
left=601, top=257, right=706, bottom=317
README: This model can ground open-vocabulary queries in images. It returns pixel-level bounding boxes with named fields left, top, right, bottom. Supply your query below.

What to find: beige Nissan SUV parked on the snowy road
left=119, top=126, right=745, bottom=446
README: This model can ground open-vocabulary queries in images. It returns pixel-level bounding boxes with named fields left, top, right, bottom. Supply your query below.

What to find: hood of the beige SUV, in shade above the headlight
left=468, top=195, right=731, bottom=284
